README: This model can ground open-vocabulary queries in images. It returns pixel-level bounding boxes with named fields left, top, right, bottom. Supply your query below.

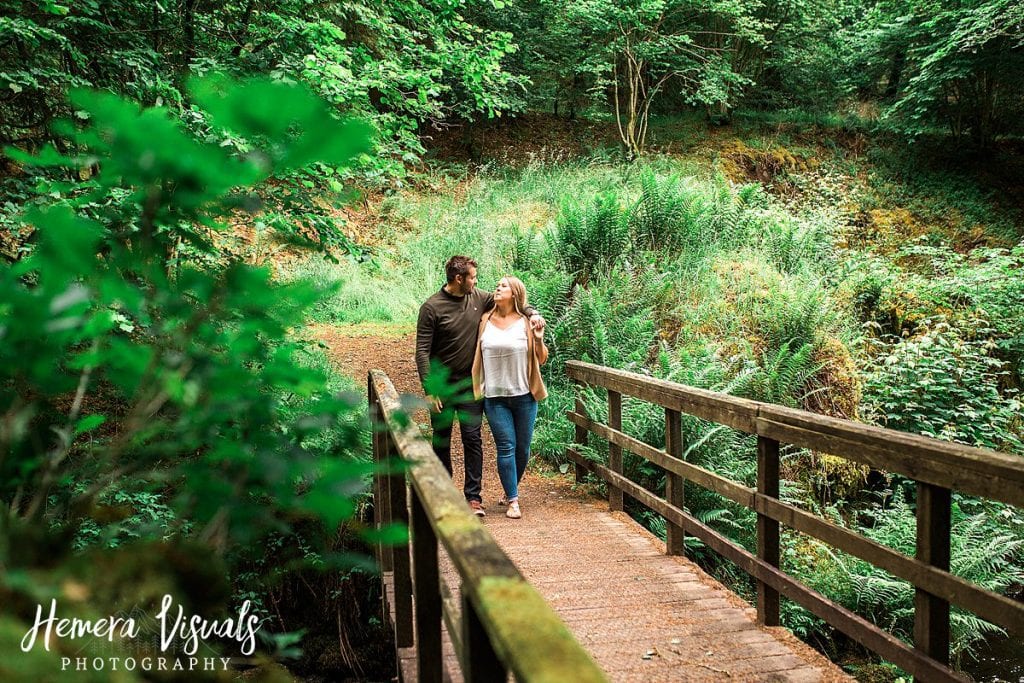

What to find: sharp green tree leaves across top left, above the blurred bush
left=0, top=0, right=523, bottom=187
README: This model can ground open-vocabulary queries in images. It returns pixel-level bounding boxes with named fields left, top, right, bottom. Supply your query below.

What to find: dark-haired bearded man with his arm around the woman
left=416, top=256, right=545, bottom=517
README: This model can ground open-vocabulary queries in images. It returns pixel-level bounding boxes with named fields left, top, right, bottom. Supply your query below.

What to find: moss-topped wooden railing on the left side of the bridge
left=367, top=370, right=606, bottom=683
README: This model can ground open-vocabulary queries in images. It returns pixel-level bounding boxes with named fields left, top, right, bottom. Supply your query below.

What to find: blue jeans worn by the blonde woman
left=483, top=393, right=537, bottom=501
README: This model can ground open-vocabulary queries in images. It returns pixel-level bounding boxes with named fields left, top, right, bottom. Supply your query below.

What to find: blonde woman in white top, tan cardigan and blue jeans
left=473, top=276, right=548, bottom=519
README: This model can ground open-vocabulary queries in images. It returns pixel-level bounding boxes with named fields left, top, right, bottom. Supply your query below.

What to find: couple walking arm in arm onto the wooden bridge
left=416, top=256, right=548, bottom=519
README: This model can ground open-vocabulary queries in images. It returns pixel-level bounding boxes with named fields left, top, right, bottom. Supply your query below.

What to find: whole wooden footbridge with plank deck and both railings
left=368, top=361, right=1024, bottom=683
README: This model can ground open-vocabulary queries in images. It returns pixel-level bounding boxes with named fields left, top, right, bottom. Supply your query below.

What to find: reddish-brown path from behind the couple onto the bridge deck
left=311, top=325, right=850, bottom=683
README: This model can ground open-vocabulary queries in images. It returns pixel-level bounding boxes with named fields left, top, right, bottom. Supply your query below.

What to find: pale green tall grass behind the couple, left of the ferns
left=286, top=161, right=635, bottom=323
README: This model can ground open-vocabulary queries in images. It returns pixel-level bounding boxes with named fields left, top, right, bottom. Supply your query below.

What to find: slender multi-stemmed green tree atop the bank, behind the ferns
left=503, top=0, right=764, bottom=154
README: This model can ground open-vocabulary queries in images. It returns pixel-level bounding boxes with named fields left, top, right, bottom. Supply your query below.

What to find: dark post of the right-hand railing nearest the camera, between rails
left=913, top=481, right=952, bottom=665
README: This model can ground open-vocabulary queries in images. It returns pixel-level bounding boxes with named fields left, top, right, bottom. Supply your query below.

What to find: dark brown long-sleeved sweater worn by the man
left=416, top=287, right=536, bottom=385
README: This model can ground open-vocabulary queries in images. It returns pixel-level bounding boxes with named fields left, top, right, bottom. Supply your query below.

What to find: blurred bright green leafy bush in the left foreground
left=0, top=79, right=373, bottom=675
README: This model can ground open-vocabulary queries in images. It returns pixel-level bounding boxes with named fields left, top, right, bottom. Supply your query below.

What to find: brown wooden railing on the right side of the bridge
left=566, top=360, right=1024, bottom=681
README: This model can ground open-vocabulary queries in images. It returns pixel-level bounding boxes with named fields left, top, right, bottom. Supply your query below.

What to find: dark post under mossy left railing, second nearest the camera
left=411, top=490, right=443, bottom=683
